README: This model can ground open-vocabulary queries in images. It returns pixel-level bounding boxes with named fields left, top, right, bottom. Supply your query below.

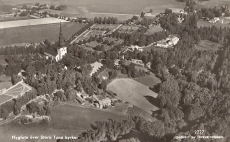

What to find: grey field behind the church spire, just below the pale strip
left=0, top=22, right=85, bottom=46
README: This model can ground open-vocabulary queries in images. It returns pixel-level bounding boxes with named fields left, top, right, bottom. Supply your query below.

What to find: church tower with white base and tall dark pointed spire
left=56, top=22, right=67, bottom=61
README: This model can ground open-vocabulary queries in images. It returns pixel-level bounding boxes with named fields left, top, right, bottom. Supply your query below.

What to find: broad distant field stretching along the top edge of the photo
left=2, top=0, right=184, bottom=14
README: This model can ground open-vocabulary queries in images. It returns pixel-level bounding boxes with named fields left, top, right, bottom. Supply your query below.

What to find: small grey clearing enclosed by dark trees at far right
left=195, top=40, right=222, bottom=51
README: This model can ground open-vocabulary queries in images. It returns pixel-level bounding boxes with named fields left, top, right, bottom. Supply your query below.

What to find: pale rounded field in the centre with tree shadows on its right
left=107, top=79, right=158, bottom=114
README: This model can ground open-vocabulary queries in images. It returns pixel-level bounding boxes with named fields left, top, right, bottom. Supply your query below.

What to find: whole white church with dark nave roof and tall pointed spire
left=44, top=23, right=67, bottom=62
